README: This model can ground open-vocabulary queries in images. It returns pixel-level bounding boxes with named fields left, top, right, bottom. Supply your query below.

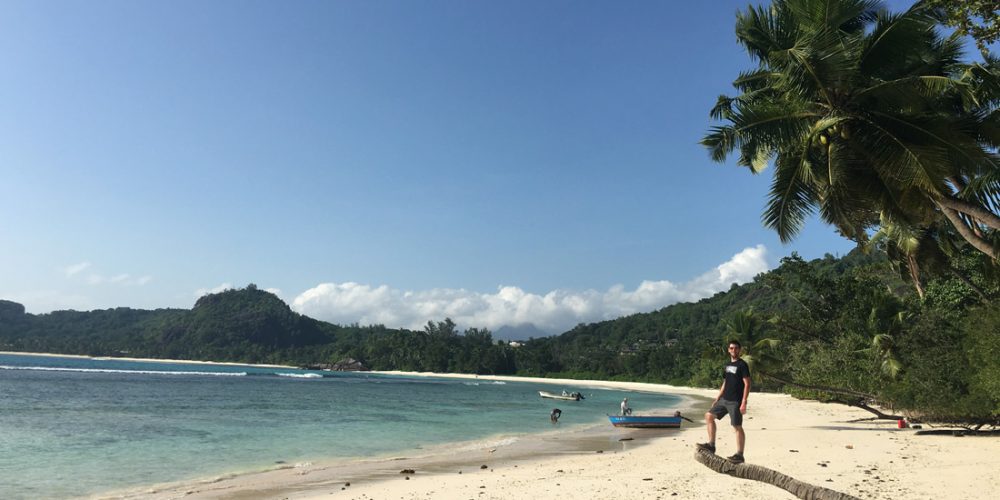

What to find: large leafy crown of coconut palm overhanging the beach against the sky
left=702, top=0, right=1000, bottom=260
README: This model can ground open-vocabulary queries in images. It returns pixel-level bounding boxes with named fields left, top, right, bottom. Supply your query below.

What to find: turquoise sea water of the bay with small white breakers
left=0, top=355, right=678, bottom=499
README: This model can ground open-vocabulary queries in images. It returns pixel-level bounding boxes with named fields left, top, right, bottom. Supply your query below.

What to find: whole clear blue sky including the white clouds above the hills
left=0, top=0, right=928, bottom=332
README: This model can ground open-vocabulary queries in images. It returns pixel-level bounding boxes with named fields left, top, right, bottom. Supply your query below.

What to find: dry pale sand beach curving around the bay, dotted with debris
left=103, top=372, right=1000, bottom=500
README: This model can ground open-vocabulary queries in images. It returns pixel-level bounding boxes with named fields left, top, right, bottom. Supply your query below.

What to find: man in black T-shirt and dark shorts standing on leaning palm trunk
left=698, top=340, right=750, bottom=464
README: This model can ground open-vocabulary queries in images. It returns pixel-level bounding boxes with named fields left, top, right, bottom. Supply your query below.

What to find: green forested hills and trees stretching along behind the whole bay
left=0, top=248, right=1000, bottom=424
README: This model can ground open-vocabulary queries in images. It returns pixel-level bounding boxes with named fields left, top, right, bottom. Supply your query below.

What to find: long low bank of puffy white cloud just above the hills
left=291, top=245, right=768, bottom=333
